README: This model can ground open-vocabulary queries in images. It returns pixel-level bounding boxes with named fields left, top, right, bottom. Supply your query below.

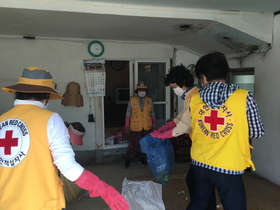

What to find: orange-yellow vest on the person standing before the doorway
left=130, top=96, right=153, bottom=131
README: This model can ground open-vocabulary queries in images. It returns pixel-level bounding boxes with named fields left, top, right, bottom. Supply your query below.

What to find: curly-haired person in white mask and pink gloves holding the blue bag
left=151, top=65, right=216, bottom=210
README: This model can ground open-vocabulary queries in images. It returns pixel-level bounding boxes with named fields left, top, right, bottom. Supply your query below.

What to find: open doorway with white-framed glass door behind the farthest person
left=103, top=60, right=170, bottom=148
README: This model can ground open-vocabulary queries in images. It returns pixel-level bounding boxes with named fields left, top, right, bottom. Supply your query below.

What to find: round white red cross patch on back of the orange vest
left=0, top=119, right=30, bottom=168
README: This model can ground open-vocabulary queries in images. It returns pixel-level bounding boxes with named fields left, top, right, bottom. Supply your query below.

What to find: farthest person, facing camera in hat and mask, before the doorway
left=124, top=82, right=156, bottom=168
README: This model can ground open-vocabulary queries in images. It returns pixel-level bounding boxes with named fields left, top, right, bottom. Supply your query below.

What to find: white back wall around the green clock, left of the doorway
left=0, top=36, right=173, bottom=150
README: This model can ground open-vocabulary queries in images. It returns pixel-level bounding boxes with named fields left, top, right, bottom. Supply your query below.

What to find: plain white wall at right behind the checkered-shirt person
left=230, top=15, right=280, bottom=185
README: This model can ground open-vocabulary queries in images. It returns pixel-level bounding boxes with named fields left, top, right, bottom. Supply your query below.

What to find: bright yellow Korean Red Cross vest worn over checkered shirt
left=190, top=89, right=255, bottom=171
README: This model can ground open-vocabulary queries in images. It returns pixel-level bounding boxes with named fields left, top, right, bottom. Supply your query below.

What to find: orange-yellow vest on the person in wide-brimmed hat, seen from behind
left=0, top=105, right=65, bottom=210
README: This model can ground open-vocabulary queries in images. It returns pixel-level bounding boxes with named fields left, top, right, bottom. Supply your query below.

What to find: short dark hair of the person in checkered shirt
left=195, top=52, right=229, bottom=81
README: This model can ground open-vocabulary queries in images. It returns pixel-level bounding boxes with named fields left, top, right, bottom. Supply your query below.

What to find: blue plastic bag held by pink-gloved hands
left=140, top=134, right=175, bottom=186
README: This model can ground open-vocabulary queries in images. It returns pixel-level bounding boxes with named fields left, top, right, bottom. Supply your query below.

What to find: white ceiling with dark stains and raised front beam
left=0, top=0, right=280, bottom=56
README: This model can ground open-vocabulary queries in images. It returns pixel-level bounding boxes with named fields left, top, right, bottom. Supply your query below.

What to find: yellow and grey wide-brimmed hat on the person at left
left=2, top=67, right=63, bottom=100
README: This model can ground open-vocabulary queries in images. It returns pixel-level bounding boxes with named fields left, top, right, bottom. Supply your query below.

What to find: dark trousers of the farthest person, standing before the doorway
left=126, top=129, right=151, bottom=160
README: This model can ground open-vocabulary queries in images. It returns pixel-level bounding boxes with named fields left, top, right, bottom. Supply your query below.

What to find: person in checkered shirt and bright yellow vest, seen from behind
left=187, top=52, right=265, bottom=210
